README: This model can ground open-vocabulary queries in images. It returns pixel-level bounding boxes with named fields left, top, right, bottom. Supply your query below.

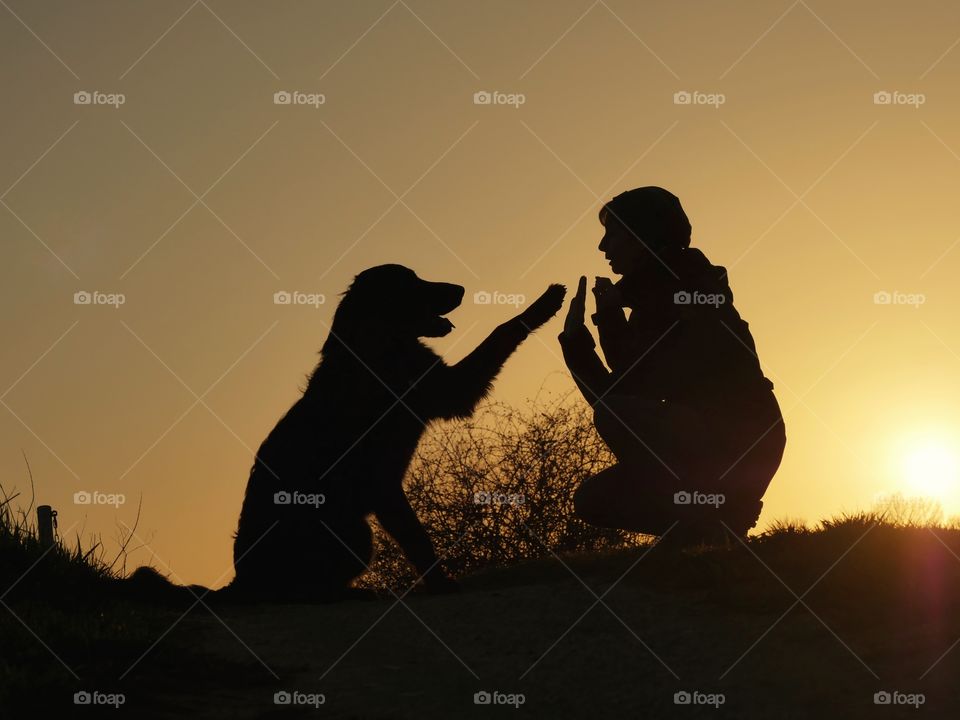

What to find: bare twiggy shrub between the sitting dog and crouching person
left=360, top=394, right=643, bottom=589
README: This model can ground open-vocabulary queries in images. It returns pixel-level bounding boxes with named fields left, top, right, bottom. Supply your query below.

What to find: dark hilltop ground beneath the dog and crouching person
left=9, top=517, right=960, bottom=719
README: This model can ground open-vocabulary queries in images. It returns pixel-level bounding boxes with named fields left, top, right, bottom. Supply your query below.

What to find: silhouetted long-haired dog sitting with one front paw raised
left=233, top=265, right=566, bottom=601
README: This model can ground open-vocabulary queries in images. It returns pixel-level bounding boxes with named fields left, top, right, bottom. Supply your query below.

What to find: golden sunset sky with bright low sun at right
left=0, top=0, right=960, bottom=586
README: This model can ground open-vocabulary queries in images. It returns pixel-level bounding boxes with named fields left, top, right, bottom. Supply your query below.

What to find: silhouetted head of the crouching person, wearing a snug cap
left=599, top=185, right=690, bottom=275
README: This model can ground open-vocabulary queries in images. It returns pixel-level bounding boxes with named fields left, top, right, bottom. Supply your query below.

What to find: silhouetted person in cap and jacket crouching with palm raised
left=559, top=187, right=786, bottom=544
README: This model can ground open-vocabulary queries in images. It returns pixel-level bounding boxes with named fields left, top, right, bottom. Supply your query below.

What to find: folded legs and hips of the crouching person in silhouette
left=574, top=395, right=785, bottom=544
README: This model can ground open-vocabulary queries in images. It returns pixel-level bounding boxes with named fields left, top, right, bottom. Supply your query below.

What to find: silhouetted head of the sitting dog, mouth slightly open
left=333, top=265, right=464, bottom=339
